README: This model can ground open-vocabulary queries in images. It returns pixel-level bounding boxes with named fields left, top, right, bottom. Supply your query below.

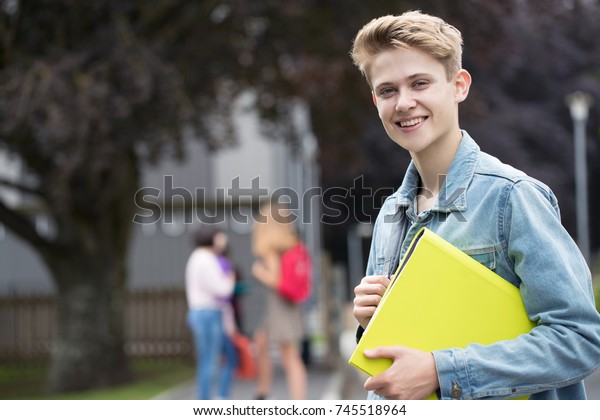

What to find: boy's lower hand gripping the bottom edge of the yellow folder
left=365, top=346, right=440, bottom=400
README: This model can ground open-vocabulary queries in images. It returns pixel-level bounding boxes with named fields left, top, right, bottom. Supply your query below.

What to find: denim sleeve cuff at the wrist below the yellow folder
left=432, top=349, right=473, bottom=400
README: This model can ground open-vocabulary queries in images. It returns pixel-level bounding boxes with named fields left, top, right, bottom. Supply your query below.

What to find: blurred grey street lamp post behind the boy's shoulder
left=566, top=91, right=592, bottom=264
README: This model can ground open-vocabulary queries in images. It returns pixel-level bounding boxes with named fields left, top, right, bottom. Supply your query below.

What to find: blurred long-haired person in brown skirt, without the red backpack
left=252, top=203, right=307, bottom=400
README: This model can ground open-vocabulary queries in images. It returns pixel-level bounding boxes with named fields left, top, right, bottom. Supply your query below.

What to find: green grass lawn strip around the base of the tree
left=0, top=360, right=195, bottom=400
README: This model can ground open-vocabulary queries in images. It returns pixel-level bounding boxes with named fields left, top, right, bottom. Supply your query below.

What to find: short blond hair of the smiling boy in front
left=350, top=11, right=463, bottom=85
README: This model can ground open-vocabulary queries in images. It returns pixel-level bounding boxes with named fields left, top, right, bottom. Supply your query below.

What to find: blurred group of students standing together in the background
left=185, top=203, right=324, bottom=400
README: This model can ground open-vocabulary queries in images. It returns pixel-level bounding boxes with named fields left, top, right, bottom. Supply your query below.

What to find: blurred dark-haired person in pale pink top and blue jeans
left=185, top=226, right=237, bottom=400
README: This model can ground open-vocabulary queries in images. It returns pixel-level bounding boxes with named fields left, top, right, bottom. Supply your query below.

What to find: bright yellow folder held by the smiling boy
left=349, top=228, right=535, bottom=398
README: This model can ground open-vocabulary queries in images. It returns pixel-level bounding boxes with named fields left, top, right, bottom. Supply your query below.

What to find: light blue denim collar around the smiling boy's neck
left=387, top=130, right=480, bottom=215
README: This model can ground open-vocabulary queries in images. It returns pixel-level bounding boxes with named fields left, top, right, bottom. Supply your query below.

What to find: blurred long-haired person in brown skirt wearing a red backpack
left=252, top=203, right=312, bottom=400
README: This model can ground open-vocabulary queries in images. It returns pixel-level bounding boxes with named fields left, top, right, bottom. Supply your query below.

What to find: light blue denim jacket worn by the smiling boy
left=367, top=131, right=600, bottom=399
